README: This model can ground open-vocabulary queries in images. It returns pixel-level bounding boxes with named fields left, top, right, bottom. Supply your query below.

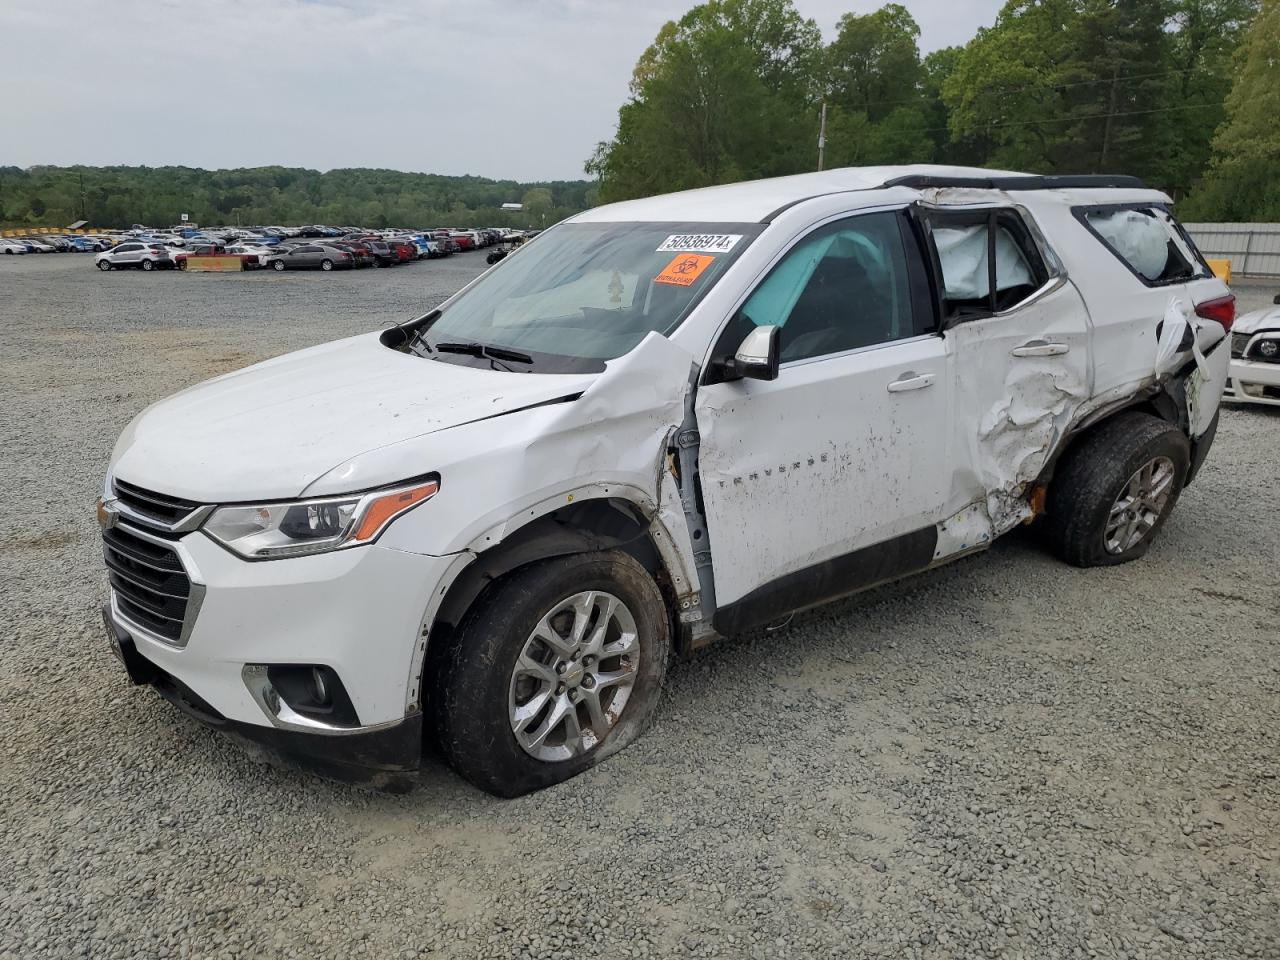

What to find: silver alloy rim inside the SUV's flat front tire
left=508, top=590, right=640, bottom=762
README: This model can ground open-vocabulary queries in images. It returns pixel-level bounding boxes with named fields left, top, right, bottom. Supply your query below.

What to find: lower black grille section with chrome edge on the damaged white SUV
left=102, top=524, right=193, bottom=643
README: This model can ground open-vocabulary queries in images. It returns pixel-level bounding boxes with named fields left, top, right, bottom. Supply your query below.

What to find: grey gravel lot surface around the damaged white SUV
left=0, top=253, right=1280, bottom=960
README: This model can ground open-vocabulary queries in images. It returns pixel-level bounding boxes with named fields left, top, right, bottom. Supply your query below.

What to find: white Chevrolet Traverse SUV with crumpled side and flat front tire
left=99, top=166, right=1234, bottom=796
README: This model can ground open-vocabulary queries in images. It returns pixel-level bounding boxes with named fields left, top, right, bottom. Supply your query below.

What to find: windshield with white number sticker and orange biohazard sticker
left=417, top=223, right=763, bottom=372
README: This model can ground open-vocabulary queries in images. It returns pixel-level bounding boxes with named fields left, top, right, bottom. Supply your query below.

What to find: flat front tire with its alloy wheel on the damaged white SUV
left=426, top=550, right=671, bottom=797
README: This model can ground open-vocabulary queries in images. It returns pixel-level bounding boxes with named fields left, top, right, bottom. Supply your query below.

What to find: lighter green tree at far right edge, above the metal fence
left=1180, top=0, right=1280, bottom=221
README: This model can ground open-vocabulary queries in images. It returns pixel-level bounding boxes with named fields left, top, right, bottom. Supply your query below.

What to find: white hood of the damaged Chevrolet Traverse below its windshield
left=111, top=333, right=596, bottom=503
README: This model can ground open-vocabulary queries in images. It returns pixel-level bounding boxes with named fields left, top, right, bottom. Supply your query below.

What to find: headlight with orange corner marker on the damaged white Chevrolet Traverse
left=202, top=480, right=440, bottom=559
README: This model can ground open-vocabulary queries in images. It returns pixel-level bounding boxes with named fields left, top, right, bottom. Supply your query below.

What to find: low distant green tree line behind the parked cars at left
left=0, top=166, right=594, bottom=228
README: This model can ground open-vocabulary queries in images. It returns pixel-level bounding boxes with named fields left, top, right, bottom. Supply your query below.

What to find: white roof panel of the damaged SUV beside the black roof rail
left=573, top=164, right=1029, bottom=223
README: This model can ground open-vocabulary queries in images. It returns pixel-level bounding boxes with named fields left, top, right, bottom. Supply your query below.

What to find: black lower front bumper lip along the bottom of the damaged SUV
left=102, top=603, right=422, bottom=790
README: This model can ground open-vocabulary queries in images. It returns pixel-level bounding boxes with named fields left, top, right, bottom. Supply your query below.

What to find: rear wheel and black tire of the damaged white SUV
left=1044, top=412, right=1190, bottom=567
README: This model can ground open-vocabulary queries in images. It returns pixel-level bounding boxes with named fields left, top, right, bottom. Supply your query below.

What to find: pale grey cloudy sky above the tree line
left=0, top=0, right=1001, bottom=180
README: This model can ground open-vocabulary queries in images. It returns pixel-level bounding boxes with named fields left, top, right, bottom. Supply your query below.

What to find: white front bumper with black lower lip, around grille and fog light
left=104, top=522, right=457, bottom=778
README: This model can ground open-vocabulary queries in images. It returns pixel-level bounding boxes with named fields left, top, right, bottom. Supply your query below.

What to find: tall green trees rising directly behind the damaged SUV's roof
left=586, top=0, right=1280, bottom=220
